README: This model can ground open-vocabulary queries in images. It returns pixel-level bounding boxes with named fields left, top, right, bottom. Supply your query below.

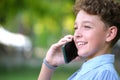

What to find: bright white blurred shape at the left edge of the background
left=0, top=26, right=32, bottom=56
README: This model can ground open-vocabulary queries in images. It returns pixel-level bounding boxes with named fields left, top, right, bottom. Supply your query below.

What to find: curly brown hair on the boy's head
left=73, top=0, right=120, bottom=46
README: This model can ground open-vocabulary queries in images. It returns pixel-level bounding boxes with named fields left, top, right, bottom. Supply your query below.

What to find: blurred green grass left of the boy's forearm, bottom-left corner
left=0, top=68, right=39, bottom=80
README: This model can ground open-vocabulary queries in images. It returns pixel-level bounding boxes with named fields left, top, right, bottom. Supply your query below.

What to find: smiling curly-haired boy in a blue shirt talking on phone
left=38, top=0, right=120, bottom=80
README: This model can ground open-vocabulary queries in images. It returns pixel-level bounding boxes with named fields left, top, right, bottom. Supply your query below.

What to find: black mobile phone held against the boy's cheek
left=62, top=40, right=78, bottom=63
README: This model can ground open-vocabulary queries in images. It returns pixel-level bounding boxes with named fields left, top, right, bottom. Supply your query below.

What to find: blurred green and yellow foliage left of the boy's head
left=0, top=0, right=74, bottom=47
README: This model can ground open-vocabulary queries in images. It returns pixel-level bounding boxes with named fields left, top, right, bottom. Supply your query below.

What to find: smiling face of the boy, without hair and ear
left=74, top=10, right=107, bottom=59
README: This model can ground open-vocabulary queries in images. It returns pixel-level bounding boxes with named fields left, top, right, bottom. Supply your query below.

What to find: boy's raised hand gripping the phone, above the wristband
left=46, top=35, right=73, bottom=66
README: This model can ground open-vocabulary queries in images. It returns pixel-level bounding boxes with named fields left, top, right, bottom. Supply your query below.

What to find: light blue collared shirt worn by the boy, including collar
left=68, top=54, right=119, bottom=80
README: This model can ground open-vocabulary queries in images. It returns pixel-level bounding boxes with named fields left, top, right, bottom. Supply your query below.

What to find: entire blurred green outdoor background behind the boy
left=0, top=0, right=120, bottom=80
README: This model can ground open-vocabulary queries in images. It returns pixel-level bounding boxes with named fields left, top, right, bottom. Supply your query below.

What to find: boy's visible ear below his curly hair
left=106, top=26, right=117, bottom=42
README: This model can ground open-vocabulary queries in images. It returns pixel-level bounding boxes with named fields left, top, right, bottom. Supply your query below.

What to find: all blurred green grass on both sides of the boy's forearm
left=0, top=67, right=78, bottom=80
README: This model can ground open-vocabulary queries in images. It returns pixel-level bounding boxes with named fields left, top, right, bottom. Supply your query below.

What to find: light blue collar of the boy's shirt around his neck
left=80, top=54, right=114, bottom=75
